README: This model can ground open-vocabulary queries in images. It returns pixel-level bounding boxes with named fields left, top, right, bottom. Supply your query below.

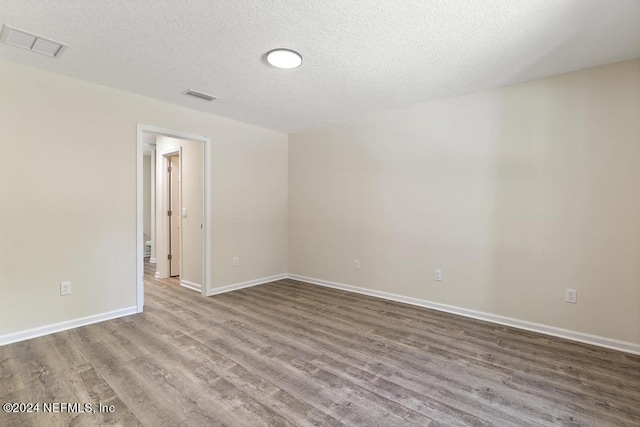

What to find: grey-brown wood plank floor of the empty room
left=0, top=262, right=640, bottom=426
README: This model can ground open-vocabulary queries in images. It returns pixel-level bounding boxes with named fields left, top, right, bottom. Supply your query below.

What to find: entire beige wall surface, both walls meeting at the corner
left=0, top=56, right=640, bottom=343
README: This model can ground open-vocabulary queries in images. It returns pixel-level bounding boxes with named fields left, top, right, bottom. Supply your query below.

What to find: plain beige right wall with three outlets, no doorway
left=288, top=60, right=640, bottom=343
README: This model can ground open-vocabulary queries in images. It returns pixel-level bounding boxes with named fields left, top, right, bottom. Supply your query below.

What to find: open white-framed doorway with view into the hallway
left=136, top=124, right=211, bottom=312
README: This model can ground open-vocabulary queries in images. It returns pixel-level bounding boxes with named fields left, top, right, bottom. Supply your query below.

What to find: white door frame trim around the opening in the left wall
left=136, top=123, right=211, bottom=313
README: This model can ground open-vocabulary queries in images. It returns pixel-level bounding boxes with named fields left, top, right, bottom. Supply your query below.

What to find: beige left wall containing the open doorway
left=0, top=62, right=287, bottom=336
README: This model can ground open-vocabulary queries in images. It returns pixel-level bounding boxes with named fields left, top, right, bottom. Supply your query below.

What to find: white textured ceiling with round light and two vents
left=0, top=0, right=640, bottom=133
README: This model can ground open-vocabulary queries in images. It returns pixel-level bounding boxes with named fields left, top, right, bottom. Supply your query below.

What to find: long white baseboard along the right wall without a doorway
left=287, top=274, right=640, bottom=354
